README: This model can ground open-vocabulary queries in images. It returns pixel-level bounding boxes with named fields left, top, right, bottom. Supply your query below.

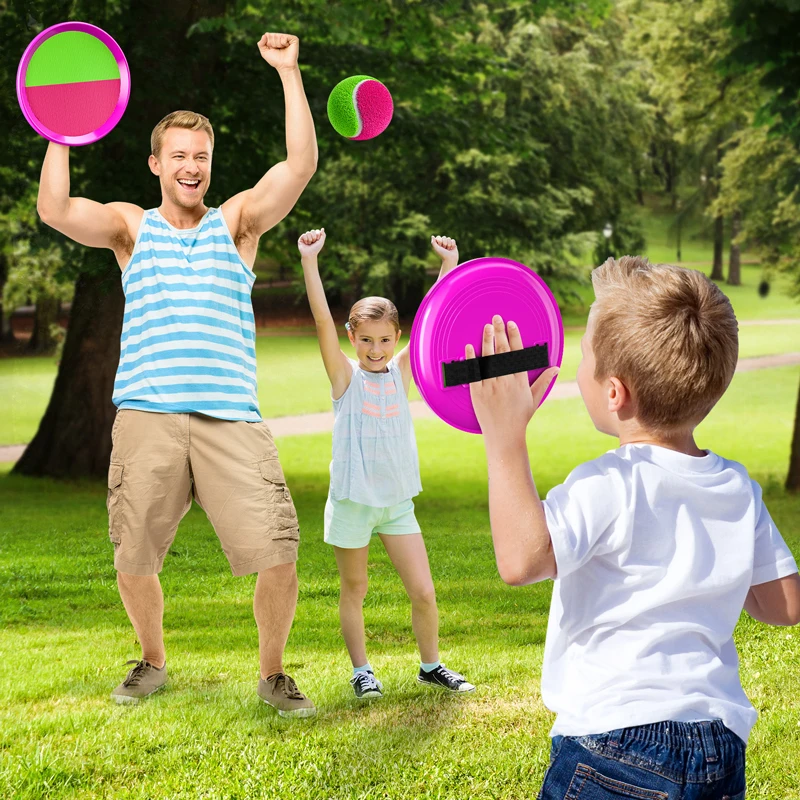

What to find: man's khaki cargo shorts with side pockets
left=103, top=409, right=300, bottom=575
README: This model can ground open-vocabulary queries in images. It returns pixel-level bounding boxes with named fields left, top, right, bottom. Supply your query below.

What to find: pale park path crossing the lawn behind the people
left=0, top=352, right=800, bottom=463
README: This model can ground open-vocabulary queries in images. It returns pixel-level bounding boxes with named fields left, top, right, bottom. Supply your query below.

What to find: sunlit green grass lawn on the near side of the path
left=0, top=367, right=800, bottom=800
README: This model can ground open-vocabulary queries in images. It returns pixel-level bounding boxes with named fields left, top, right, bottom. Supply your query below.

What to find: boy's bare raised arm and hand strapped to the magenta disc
left=466, top=316, right=558, bottom=586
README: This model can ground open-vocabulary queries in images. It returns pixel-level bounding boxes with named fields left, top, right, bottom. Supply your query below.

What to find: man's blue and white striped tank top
left=112, top=208, right=261, bottom=422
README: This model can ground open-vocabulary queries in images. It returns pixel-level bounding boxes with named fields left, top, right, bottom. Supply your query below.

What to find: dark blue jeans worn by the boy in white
left=539, top=720, right=745, bottom=800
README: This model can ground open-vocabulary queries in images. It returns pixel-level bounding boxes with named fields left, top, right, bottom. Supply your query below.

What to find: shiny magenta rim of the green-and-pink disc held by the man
left=17, top=22, right=131, bottom=147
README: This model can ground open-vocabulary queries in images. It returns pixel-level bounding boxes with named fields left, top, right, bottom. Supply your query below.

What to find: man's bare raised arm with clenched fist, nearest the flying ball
left=223, top=33, right=317, bottom=239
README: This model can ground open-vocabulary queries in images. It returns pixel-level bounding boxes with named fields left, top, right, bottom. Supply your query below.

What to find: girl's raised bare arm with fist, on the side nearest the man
left=298, top=228, right=353, bottom=400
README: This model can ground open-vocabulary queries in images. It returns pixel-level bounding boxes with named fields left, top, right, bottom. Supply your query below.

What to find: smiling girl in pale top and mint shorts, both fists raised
left=297, top=228, right=475, bottom=699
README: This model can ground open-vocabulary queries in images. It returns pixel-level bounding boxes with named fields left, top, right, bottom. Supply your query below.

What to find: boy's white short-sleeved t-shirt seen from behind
left=542, top=444, right=797, bottom=742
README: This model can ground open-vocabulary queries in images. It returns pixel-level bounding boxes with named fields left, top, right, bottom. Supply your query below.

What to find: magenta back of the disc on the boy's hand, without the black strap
left=409, top=257, right=564, bottom=433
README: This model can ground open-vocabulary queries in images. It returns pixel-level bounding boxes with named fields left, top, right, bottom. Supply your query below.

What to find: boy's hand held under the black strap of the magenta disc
left=465, top=316, right=558, bottom=438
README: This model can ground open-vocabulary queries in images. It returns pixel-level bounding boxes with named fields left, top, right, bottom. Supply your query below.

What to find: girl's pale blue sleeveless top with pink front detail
left=330, top=359, right=422, bottom=508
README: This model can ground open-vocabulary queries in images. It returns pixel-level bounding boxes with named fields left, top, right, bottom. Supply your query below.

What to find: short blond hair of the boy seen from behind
left=590, top=256, right=739, bottom=433
